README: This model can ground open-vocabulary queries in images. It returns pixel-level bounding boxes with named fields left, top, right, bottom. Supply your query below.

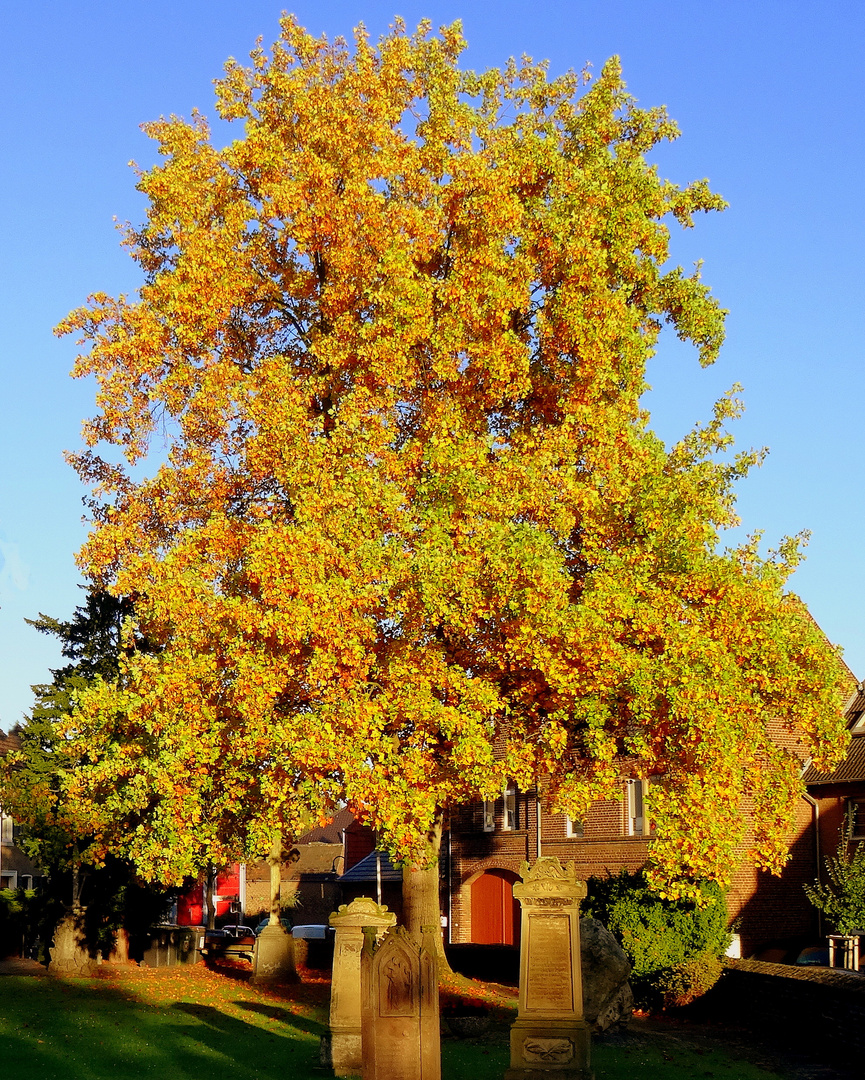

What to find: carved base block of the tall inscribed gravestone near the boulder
left=504, top=1020, right=594, bottom=1080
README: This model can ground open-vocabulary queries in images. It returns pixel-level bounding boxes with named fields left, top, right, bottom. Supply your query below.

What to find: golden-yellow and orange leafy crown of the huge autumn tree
left=59, top=17, right=843, bottom=911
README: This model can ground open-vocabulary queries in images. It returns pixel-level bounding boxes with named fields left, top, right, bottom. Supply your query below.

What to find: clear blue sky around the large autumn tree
left=0, top=0, right=865, bottom=729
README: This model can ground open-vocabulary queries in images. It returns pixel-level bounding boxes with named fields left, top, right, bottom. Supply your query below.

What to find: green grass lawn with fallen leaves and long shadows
left=0, top=967, right=783, bottom=1080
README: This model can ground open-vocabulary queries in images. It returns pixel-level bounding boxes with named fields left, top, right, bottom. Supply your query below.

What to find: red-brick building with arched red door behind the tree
left=443, top=685, right=865, bottom=956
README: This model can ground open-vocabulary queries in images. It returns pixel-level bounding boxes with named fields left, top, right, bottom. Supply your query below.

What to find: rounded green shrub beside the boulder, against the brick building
left=583, top=870, right=730, bottom=1008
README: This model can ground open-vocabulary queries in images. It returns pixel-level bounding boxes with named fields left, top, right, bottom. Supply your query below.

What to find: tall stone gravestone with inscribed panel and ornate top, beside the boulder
left=504, top=855, right=592, bottom=1080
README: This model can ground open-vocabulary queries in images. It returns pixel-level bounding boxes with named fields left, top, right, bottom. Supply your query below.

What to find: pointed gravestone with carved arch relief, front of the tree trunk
left=361, top=927, right=442, bottom=1080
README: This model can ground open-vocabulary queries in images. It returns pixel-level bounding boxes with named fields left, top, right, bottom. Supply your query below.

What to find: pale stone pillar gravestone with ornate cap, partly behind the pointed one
left=322, top=896, right=396, bottom=1077
